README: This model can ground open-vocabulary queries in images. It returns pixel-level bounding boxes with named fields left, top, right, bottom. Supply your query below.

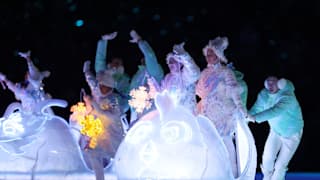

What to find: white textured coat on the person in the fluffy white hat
left=196, top=63, right=244, bottom=136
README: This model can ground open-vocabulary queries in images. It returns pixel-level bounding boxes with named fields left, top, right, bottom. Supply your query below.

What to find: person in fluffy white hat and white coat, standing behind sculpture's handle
left=196, top=37, right=248, bottom=177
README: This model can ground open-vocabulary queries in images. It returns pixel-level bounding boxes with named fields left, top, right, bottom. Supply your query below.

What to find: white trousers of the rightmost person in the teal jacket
left=261, top=129, right=302, bottom=180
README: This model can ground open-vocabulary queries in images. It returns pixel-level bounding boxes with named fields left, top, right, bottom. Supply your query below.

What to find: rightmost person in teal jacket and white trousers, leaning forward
left=249, top=76, right=304, bottom=180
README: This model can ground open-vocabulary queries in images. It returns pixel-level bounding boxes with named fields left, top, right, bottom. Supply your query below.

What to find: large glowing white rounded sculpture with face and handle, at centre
left=113, top=92, right=256, bottom=179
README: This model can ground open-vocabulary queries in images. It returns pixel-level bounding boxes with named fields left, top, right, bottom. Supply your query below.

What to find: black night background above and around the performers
left=0, top=0, right=320, bottom=172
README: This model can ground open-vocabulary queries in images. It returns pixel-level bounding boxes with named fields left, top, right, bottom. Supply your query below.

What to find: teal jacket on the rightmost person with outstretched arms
left=249, top=80, right=304, bottom=137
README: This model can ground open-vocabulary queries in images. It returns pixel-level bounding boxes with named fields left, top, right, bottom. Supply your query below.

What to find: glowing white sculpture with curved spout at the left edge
left=0, top=99, right=114, bottom=180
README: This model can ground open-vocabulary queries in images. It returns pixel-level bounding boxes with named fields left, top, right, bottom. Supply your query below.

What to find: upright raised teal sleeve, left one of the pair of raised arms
left=94, top=39, right=108, bottom=73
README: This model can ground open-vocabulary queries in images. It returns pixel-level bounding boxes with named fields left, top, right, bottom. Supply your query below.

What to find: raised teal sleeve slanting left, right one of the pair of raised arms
left=138, top=40, right=164, bottom=82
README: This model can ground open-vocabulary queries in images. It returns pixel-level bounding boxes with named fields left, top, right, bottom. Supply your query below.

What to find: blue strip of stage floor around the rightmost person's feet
left=255, top=172, right=320, bottom=180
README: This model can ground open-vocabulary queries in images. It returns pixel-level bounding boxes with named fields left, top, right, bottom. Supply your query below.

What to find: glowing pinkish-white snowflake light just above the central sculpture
left=129, top=86, right=152, bottom=113
